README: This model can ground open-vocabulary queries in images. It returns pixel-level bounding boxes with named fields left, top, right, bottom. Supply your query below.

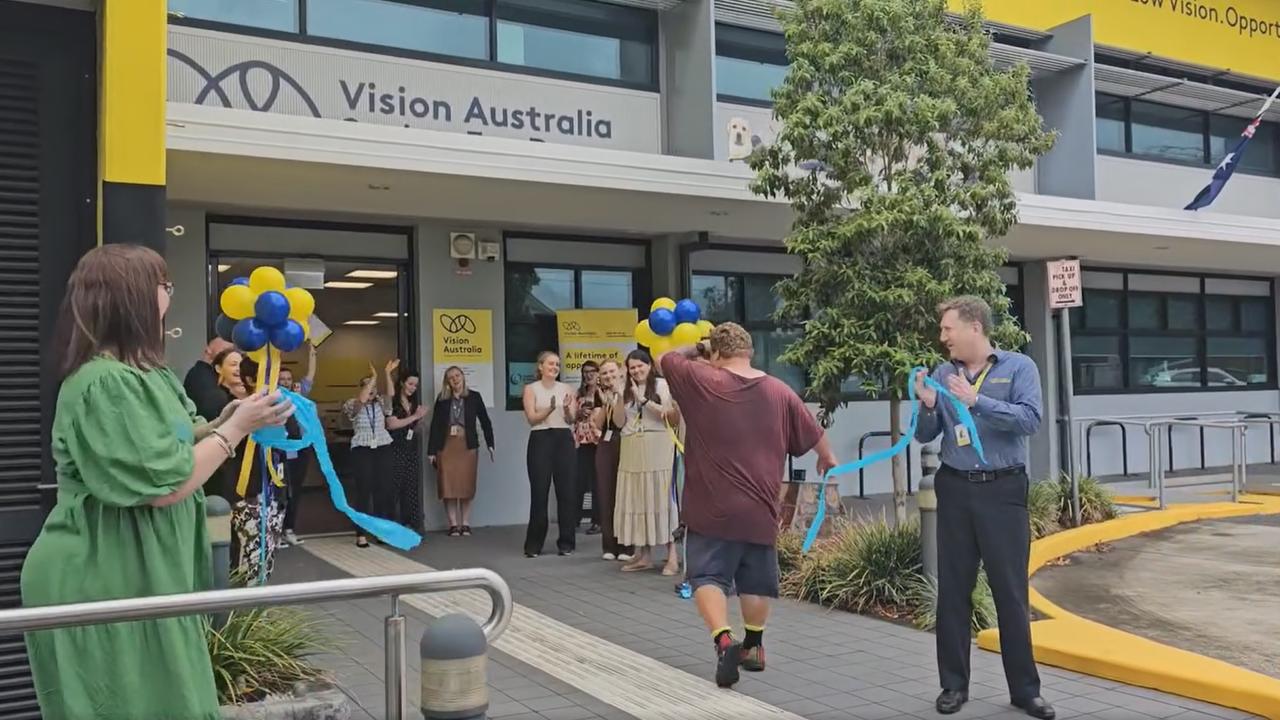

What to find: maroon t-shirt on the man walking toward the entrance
left=662, top=352, right=822, bottom=544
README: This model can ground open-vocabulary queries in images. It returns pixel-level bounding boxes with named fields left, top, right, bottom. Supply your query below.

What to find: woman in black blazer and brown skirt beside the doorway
left=426, top=366, right=493, bottom=537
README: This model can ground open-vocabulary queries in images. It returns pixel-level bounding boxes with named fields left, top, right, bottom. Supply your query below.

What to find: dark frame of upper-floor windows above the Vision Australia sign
left=169, top=0, right=660, bottom=92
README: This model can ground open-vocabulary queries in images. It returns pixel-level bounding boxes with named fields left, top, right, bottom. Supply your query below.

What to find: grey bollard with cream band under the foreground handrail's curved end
left=421, top=614, right=489, bottom=720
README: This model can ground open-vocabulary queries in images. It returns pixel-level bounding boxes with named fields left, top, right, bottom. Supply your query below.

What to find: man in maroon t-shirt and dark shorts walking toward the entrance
left=659, top=323, right=836, bottom=688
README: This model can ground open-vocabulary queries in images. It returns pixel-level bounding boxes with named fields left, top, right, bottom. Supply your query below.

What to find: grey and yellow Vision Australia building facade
left=0, top=0, right=1280, bottom=716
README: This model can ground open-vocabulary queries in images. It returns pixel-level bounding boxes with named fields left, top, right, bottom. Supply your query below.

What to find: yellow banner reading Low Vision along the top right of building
left=948, top=0, right=1280, bottom=79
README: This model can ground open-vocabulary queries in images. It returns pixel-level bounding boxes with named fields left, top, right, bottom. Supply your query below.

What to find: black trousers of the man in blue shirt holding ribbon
left=934, top=465, right=1041, bottom=701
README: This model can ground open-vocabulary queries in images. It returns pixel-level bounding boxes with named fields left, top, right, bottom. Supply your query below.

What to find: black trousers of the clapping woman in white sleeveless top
left=525, top=428, right=582, bottom=555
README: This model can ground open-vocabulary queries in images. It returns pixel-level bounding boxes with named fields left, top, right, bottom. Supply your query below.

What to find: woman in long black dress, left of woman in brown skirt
left=387, top=360, right=428, bottom=533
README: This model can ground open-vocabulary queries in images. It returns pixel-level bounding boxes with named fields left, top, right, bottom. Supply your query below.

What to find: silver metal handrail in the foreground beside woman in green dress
left=0, top=568, right=515, bottom=720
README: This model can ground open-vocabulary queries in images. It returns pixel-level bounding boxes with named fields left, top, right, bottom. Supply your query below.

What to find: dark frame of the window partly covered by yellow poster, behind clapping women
left=494, top=231, right=653, bottom=411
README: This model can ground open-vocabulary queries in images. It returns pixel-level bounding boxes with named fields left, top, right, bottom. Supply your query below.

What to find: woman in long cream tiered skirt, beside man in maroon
left=613, top=350, right=680, bottom=575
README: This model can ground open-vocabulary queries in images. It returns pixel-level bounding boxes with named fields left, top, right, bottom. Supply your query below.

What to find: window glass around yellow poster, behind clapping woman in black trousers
left=506, top=263, right=643, bottom=410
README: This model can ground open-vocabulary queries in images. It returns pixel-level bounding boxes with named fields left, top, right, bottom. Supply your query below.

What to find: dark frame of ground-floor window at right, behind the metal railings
left=1070, top=266, right=1280, bottom=396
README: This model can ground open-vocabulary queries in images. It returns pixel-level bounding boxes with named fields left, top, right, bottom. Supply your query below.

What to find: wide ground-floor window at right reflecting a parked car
left=1071, top=272, right=1275, bottom=393
